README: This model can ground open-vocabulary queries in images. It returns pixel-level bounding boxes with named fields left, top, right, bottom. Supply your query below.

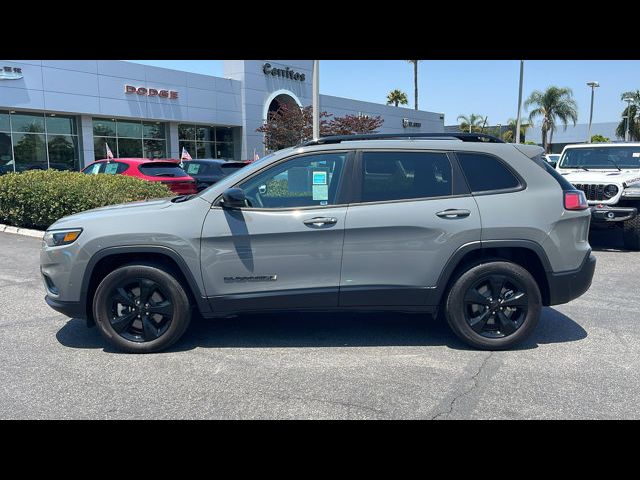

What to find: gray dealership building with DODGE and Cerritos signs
left=0, top=60, right=444, bottom=173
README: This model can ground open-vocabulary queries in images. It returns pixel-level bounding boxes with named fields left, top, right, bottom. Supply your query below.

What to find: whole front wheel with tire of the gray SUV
left=93, top=264, right=191, bottom=353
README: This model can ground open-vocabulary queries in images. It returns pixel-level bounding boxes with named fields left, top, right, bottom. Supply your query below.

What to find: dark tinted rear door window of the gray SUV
left=362, top=152, right=452, bottom=202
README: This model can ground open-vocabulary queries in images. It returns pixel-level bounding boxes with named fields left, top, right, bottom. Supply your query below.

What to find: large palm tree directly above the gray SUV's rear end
left=524, top=87, right=578, bottom=153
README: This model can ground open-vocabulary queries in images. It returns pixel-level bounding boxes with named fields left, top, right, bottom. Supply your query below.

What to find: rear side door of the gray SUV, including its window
left=340, top=150, right=481, bottom=306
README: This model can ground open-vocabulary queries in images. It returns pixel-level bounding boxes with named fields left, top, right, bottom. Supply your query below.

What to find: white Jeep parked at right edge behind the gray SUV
left=557, top=143, right=640, bottom=250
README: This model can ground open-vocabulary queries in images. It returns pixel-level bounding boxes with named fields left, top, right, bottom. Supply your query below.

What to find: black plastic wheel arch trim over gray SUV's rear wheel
left=432, top=240, right=552, bottom=306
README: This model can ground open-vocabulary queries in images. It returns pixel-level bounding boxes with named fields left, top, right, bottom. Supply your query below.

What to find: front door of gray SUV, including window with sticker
left=201, top=152, right=351, bottom=311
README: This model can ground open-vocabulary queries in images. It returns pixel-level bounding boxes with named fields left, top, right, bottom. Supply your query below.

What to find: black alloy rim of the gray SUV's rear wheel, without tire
left=464, top=274, right=529, bottom=338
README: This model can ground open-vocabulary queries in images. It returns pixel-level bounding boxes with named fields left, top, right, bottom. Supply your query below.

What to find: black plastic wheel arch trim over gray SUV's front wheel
left=80, top=245, right=211, bottom=325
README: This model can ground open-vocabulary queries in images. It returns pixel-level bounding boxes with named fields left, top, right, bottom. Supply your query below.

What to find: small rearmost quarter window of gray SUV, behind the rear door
left=456, top=152, right=520, bottom=193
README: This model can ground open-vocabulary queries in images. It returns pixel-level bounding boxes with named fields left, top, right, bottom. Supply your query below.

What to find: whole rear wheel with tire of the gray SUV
left=444, top=260, right=542, bottom=350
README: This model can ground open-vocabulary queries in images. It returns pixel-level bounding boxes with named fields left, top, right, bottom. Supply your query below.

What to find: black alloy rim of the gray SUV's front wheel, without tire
left=109, top=278, right=173, bottom=342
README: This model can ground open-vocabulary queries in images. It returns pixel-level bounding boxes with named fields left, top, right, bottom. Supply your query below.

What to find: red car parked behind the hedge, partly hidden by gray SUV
left=82, top=158, right=198, bottom=195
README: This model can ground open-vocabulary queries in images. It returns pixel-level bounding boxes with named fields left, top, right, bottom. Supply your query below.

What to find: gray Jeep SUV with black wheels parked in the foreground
left=41, top=134, right=595, bottom=352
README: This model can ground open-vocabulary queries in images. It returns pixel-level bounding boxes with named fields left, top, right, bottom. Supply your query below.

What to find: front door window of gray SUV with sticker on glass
left=238, top=152, right=347, bottom=208
